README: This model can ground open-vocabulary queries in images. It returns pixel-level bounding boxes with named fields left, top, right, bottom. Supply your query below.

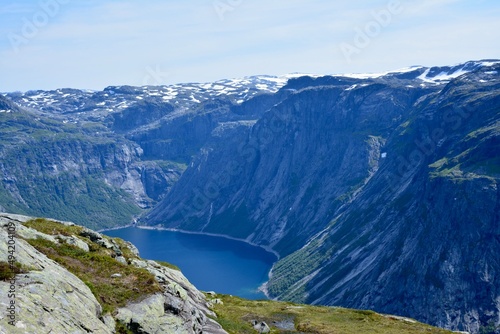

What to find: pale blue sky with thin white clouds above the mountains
left=0, top=0, right=500, bottom=92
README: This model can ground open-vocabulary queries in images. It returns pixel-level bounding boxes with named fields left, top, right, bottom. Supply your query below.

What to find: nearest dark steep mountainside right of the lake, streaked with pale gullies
left=269, top=66, right=500, bottom=333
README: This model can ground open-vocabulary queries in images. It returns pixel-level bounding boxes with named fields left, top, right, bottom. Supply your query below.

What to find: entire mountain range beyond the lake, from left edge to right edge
left=0, top=60, right=500, bottom=333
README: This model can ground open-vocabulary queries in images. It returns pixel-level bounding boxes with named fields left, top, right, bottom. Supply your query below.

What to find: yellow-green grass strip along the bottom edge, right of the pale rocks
left=213, top=295, right=452, bottom=334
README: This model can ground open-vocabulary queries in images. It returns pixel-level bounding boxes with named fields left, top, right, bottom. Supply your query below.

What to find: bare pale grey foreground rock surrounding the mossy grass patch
left=0, top=214, right=226, bottom=334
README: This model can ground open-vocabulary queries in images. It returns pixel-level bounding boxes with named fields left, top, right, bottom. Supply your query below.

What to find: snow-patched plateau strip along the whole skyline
left=0, top=60, right=500, bottom=124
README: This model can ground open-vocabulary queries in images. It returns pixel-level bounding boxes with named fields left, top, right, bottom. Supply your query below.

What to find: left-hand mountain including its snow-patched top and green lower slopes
left=0, top=76, right=287, bottom=229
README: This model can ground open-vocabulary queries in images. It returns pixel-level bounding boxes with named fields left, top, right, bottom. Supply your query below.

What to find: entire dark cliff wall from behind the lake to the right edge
left=145, top=62, right=500, bottom=333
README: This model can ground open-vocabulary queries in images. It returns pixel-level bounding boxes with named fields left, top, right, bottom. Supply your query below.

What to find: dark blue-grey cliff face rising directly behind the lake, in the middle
left=146, top=82, right=432, bottom=254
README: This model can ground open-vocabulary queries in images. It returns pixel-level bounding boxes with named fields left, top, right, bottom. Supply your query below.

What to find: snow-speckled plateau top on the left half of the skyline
left=5, top=75, right=300, bottom=124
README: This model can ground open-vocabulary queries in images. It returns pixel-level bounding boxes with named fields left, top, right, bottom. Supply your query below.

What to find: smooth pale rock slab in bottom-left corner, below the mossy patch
left=0, top=215, right=111, bottom=334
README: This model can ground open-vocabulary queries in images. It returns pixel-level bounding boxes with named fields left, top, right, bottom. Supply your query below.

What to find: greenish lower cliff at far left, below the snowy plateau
left=0, top=102, right=166, bottom=228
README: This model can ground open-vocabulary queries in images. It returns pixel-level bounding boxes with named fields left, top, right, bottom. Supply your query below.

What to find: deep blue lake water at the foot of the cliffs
left=104, top=227, right=276, bottom=299
